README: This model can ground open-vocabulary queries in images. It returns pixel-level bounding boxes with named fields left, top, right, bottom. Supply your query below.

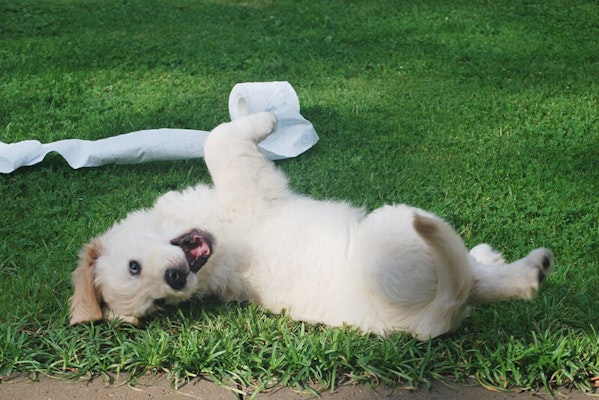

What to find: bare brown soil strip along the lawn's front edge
left=0, top=375, right=596, bottom=400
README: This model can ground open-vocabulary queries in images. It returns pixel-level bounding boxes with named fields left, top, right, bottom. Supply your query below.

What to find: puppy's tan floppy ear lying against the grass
left=70, top=238, right=102, bottom=325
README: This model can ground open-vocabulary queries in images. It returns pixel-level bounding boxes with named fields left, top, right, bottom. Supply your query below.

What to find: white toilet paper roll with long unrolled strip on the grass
left=0, top=82, right=318, bottom=174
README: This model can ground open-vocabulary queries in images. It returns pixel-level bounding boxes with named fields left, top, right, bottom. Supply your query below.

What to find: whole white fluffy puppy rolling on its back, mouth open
left=71, top=112, right=554, bottom=340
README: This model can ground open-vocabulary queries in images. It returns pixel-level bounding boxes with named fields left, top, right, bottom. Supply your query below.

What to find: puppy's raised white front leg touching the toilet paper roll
left=204, top=112, right=289, bottom=205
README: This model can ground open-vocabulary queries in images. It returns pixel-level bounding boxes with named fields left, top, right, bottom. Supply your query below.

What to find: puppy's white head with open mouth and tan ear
left=70, top=212, right=214, bottom=325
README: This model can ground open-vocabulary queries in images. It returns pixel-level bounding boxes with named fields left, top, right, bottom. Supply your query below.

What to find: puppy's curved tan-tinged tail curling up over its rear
left=413, top=213, right=472, bottom=336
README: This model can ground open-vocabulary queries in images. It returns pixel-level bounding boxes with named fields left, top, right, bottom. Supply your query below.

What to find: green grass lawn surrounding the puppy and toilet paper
left=0, top=0, right=599, bottom=391
